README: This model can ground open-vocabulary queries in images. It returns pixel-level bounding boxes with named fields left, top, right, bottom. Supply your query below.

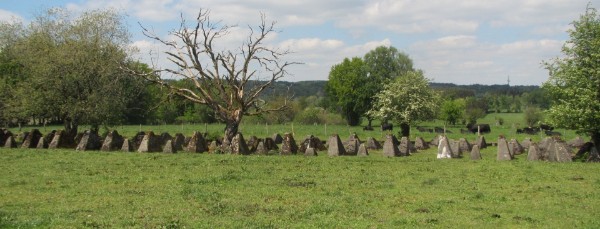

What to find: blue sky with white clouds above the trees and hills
left=0, top=0, right=600, bottom=85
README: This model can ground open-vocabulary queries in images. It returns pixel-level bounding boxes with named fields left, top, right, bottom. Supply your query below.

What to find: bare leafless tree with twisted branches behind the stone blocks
left=126, top=10, right=299, bottom=140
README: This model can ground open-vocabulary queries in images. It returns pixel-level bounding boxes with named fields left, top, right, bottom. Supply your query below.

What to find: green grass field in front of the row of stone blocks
left=0, top=148, right=600, bottom=228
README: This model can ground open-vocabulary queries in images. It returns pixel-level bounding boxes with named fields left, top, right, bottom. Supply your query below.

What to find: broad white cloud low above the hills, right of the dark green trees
left=410, top=36, right=564, bottom=85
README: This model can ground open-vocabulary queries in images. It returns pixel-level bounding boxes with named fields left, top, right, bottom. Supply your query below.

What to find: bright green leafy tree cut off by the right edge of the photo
left=543, top=5, right=600, bottom=150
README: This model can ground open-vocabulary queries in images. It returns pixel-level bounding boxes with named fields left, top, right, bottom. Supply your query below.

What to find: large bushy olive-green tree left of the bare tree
left=1, top=8, right=143, bottom=135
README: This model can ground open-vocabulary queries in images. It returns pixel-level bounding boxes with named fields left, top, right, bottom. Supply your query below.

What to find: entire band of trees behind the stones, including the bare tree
left=0, top=5, right=600, bottom=155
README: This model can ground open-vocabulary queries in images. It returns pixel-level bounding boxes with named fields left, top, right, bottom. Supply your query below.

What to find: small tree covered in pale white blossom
left=369, top=71, right=440, bottom=136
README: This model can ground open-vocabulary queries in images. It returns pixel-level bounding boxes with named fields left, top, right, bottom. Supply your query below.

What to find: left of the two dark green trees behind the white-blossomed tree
left=325, top=57, right=372, bottom=126
